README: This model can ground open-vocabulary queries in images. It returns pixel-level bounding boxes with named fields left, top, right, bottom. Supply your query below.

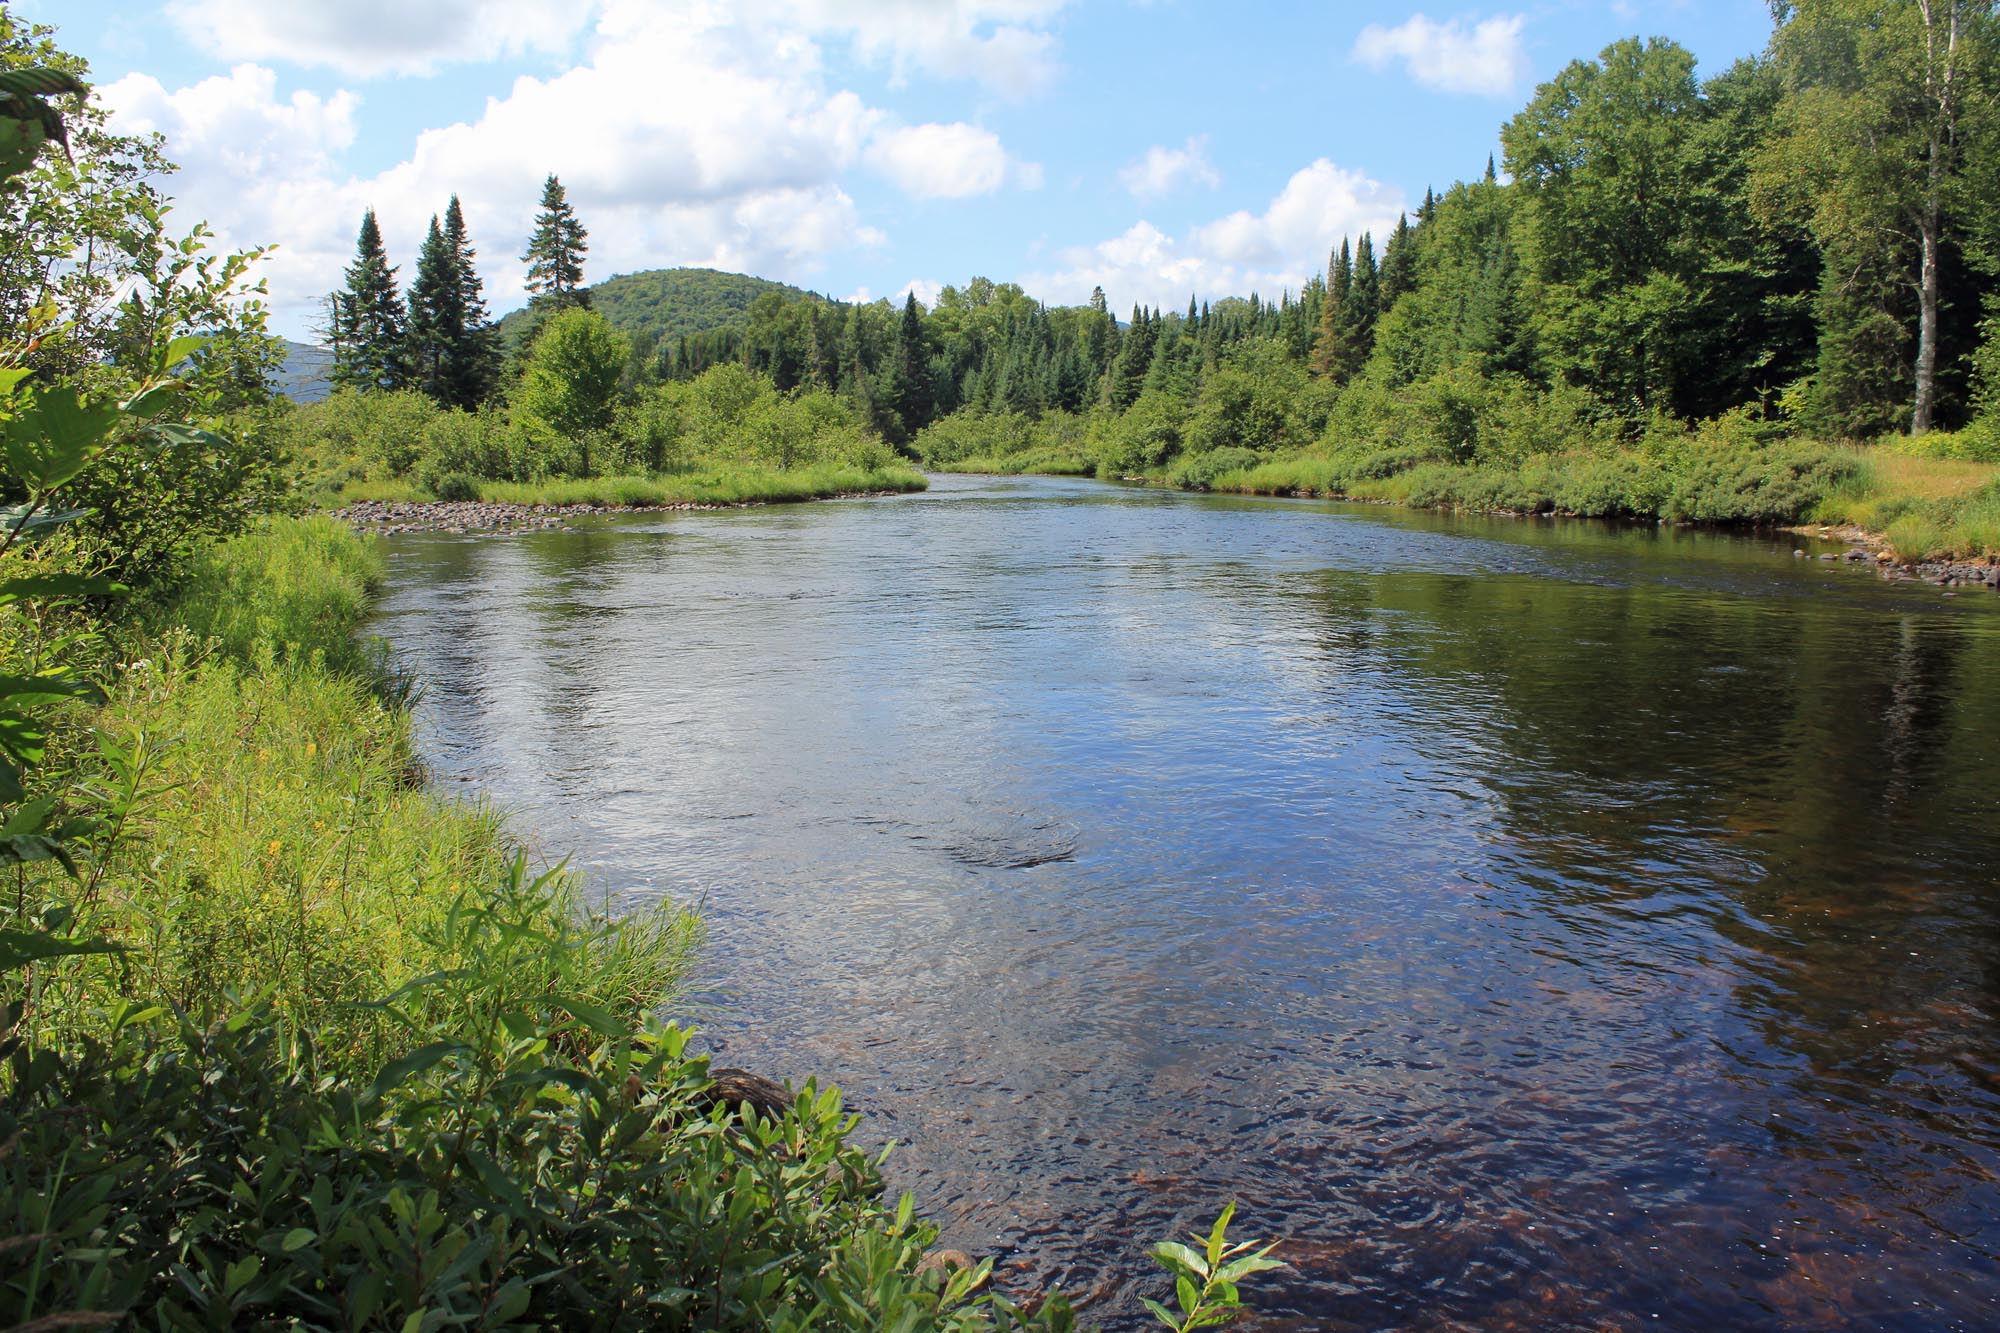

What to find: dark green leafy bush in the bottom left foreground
left=0, top=877, right=1070, bottom=1329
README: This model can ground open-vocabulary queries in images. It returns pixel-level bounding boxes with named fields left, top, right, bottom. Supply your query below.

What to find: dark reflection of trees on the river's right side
left=1288, top=560, right=2000, bottom=1245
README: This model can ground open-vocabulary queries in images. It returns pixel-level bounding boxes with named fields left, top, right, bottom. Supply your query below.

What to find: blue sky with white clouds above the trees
left=11, top=0, right=1770, bottom=340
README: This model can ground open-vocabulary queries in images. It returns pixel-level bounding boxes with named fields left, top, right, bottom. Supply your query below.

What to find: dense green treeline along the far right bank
left=700, top=15, right=2000, bottom=462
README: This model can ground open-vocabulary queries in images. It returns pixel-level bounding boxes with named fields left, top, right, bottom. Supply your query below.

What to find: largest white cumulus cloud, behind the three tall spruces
left=102, top=0, right=1080, bottom=334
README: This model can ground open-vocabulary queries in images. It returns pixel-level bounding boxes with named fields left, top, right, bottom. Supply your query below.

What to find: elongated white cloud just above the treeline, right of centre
left=1022, top=158, right=1408, bottom=310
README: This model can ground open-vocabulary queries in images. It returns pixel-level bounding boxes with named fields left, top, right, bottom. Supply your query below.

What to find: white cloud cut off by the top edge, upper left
left=166, top=0, right=592, bottom=78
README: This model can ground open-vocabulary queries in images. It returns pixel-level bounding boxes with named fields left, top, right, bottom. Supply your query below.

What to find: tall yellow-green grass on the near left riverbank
left=32, top=518, right=700, bottom=1071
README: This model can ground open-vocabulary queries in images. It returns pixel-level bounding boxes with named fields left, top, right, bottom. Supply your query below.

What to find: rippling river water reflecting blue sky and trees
left=380, top=478, right=2000, bottom=1329
